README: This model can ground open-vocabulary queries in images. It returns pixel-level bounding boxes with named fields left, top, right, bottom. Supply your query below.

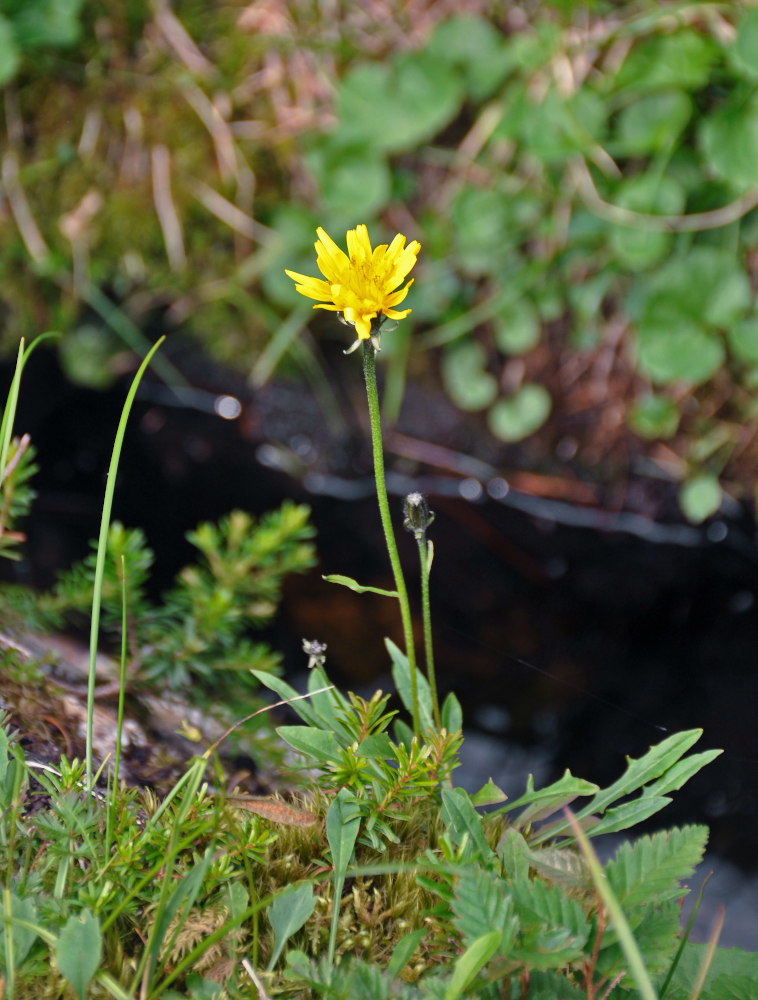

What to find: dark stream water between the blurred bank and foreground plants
left=5, top=342, right=758, bottom=944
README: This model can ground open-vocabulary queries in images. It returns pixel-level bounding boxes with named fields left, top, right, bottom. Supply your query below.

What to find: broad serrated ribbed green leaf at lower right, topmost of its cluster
left=605, top=826, right=708, bottom=910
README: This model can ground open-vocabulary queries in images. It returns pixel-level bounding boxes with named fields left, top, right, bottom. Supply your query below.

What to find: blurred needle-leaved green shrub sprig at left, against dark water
left=40, top=502, right=315, bottom=701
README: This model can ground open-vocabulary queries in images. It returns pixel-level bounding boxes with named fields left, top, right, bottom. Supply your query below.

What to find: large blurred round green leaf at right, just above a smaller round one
left=637, top=319, right=724, bottom=385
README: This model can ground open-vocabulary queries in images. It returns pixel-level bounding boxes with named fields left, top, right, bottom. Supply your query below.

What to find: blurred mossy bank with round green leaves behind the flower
left=0, top=0, right=758, bottom=518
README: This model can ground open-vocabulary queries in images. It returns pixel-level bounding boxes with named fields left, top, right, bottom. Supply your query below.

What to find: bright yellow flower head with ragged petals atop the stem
left=285, top=225, right=421, bottom=350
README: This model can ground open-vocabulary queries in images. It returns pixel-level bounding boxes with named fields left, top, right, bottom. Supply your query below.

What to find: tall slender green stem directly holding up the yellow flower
left=363, top=340, right=420, bottom=736
